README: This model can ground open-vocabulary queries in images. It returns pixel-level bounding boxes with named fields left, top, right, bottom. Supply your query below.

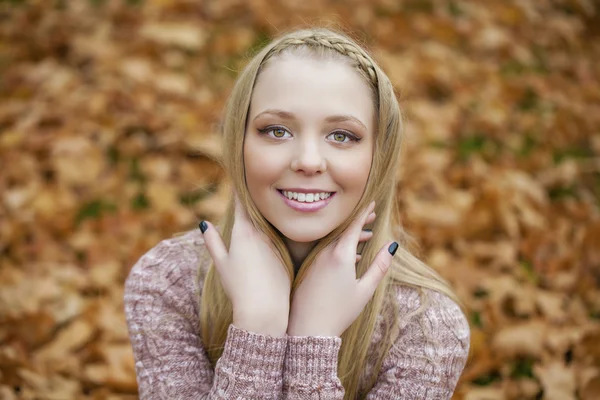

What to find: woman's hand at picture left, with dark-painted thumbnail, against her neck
left=200, top=196, right=291, bottom=336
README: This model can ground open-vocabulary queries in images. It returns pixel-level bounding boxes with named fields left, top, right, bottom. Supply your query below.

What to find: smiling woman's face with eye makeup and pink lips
left=244, top=56, right=375, bottom=243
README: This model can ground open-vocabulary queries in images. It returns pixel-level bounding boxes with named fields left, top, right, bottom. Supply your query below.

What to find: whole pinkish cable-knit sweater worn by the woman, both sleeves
left=125, top=230, right=470, bottom=400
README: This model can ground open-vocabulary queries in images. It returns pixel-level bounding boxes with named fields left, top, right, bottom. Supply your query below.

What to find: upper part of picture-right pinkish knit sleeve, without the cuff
left=367, top=290, right=470, bottom=400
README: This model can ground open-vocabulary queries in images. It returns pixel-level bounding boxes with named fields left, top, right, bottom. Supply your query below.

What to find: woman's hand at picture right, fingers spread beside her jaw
left=287, top=202, right=398, bottom=336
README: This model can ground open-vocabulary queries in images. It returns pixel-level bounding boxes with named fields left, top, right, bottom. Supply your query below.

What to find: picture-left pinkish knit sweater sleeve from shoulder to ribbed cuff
left=124, top=233, right=287, bottom=400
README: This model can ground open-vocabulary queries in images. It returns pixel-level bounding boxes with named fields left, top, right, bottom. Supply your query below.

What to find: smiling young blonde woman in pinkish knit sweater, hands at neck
left=125, top=29, right=470, bottom=400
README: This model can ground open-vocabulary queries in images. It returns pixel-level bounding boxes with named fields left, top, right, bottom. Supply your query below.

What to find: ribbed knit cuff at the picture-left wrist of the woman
left=219, top=324, right=287, bottom=382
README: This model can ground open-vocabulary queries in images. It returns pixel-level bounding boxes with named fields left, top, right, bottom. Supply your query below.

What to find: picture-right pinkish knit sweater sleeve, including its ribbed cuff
left=283, top=289, right=470, bottom=400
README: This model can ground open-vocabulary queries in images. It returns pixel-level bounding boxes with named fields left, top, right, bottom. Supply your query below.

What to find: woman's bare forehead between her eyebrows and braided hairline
left=250, top=56, right=375, bottom=129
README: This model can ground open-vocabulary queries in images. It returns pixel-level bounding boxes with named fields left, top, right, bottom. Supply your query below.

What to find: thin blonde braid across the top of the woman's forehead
left=263, top=33, right=377, bottom=87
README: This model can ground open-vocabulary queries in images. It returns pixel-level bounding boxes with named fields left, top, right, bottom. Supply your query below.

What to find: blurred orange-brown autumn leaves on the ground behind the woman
left=0, top=0, right=600, bottom=400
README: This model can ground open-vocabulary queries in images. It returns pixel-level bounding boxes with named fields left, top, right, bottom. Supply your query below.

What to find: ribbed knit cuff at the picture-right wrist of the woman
left=284, top=336, right=342, bottom=382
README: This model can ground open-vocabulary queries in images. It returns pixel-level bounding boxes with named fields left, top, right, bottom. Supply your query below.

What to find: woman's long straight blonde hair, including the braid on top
left=198, top=28, right=460, bottom=399
